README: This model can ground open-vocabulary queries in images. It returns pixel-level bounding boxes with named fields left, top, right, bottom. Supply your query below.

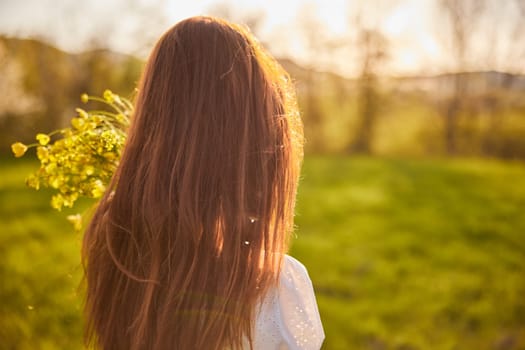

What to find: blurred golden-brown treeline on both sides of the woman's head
left=0, top=37, right=525, bottom=159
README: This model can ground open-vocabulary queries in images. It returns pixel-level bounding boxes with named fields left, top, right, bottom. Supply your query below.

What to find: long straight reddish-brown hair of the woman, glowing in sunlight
left=82, top=17, right=303, bottom=350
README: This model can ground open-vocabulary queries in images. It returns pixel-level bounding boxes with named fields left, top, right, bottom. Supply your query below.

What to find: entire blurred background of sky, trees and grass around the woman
left=0, top=0, right=525, bottom=350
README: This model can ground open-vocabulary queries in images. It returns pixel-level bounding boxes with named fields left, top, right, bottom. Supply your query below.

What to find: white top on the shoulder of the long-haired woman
left=247, top=255, right=325, bottom=350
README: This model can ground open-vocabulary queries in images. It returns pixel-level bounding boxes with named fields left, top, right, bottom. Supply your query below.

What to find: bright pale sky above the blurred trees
left=0, top=0, right=525, bottom=76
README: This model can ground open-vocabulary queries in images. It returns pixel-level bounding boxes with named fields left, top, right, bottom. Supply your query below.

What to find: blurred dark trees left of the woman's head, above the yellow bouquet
left=0, top=37, right=143, bottom=153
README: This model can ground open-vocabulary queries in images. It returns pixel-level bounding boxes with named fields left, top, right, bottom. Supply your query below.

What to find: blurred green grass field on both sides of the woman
left=0, top=157, right=525, bottom=350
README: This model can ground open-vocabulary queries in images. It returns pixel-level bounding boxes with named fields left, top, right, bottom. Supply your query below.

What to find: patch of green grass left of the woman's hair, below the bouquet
left=0, top=159, right=86, bottom=350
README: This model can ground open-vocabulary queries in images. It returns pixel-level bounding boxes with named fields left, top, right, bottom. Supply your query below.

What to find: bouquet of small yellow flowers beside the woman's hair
left=11, top=90, right=133, bottom=228
